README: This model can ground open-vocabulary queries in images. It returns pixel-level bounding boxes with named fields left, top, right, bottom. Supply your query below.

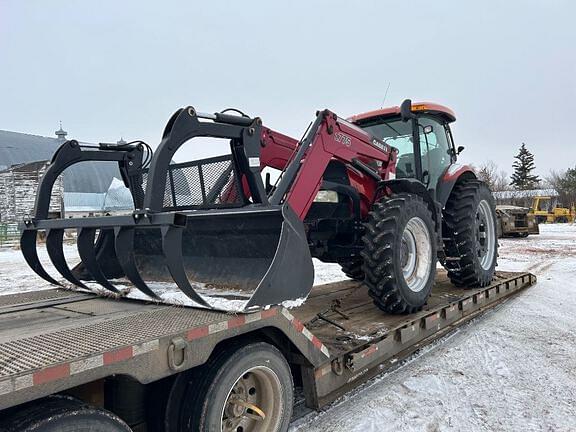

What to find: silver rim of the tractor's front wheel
left=400, top=217, right=432, bottom=292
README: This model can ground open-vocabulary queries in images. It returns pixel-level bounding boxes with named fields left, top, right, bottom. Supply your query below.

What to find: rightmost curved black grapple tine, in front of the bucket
left=162, top=226, right=210, bottom=306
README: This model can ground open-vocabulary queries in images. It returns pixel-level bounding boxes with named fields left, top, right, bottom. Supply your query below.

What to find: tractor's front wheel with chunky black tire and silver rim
left=362, top=193, right=436, bottom=314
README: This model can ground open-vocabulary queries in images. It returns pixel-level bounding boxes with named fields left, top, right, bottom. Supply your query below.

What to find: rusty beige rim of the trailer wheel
left=221, top=366, right=284, bottom=432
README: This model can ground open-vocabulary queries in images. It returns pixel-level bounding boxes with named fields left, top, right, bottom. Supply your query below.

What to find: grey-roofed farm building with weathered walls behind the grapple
left=0, top=127, right=131, bottom=223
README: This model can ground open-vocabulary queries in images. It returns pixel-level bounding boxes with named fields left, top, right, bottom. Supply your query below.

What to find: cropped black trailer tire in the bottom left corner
left=0, top=395, right=131, bottom=432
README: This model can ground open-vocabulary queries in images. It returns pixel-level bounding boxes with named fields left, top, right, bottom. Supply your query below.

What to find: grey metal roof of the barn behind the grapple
left=0, top=130, right=120, bottom=193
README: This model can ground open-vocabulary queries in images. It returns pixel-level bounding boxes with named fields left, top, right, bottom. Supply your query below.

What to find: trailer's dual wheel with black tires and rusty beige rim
left=165, top=342, right=294, bottom=432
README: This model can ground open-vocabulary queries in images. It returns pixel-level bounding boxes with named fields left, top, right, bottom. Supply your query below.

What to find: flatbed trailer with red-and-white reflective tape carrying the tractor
left=0, top=271, right=536, bottom=431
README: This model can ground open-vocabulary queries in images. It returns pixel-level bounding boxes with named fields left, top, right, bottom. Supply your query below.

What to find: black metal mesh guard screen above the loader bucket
left=134, top=155, right=245, bottom=211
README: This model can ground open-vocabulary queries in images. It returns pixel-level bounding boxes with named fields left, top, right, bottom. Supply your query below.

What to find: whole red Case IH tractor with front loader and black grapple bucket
left=21, top=100, right=497, bottom=313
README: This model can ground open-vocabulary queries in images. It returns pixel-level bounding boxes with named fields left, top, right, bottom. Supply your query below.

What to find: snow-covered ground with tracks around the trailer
left=0, top=224, right=576, bottom=432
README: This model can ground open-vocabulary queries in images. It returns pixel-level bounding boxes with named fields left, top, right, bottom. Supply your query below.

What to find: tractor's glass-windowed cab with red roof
left=350, top=100, right=463, bottom=201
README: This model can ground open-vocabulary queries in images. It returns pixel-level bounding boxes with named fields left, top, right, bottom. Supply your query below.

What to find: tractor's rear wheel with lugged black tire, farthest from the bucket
left=442, top=180, right=498, bottom=288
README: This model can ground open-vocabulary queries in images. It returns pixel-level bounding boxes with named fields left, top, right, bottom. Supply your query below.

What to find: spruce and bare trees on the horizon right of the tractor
left=476, top=143, right=576, bottom=205
